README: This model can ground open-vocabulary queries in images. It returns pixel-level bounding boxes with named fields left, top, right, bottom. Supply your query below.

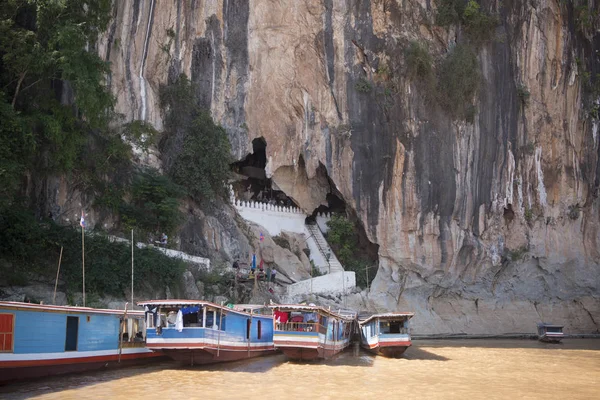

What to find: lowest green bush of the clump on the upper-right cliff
left=438, top=44, right=481, bottom=122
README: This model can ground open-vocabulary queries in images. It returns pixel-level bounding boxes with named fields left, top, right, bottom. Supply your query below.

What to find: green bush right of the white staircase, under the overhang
left=327, top=215, right=377, bottom=288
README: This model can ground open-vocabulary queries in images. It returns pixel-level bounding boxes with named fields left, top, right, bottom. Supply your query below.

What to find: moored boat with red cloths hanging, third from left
left=270, top=304, right=356, bottom=361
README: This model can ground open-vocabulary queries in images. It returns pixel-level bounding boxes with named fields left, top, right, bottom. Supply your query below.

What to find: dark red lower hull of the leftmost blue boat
left=0, top=350, right=166, bottom=385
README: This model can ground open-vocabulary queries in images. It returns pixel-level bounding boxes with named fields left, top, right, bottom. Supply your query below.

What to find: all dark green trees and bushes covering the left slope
left=0, top=0, right=196, bottom=295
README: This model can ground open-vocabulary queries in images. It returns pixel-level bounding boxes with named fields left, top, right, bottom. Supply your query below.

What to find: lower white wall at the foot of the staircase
left=286, top=271, right=356, bottom=300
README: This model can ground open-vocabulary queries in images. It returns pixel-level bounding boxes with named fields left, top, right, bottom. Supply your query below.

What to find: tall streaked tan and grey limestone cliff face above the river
left=99, top=0, right=600, bottom=333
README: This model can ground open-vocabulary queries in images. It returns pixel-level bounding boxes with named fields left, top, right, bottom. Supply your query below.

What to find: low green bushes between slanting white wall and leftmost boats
left=0, top=206, right=184, bottom=296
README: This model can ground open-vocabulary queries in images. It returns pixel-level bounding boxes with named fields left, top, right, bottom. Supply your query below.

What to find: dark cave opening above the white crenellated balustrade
left=231, top=137, right=296, bottom=207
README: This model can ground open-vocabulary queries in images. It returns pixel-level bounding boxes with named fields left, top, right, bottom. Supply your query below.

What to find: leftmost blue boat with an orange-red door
left=0, top=302, right=162, bottom=383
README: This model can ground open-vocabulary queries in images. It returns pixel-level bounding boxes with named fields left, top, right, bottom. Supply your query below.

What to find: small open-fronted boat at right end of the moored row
left=358, top=313, right=414, bottom=357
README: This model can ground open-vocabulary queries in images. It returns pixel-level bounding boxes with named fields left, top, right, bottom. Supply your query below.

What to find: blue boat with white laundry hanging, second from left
left=138, top=300, right=275, bottom=365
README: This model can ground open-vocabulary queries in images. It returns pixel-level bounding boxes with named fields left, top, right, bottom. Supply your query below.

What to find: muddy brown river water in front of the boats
left=0, top=339, right=600, bottom=400
